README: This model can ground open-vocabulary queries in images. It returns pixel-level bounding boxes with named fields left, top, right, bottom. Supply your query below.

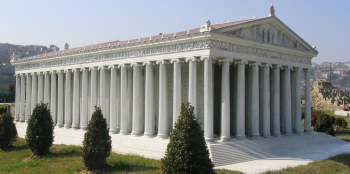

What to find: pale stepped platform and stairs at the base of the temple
left=16, top=123, right=350, bottom=173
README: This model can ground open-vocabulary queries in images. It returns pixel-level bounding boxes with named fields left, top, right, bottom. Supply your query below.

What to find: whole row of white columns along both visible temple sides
left=15, top=56, right=311, bottom=141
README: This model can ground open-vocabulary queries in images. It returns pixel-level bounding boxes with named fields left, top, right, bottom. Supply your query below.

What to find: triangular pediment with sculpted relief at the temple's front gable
left=215, top=16, right=317, bottom=53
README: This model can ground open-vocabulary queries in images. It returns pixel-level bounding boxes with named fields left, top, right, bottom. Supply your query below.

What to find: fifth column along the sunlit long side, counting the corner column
left=144, top=62, right=155, bottom=137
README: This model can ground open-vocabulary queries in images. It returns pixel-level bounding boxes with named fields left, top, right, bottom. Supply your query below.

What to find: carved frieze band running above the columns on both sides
left=14, top=39, right=311, bottom=70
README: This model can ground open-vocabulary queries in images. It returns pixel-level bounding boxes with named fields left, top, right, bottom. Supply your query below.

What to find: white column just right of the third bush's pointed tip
left=99, top=67, right=109, bottom=122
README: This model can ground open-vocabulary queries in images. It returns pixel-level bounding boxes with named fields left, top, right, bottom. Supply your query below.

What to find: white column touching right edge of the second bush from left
left=50, top=71, right=57, bottom=125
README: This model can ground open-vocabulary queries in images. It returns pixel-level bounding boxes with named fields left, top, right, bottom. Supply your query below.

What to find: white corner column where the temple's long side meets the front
left=201, top=56, right=214, bottom=142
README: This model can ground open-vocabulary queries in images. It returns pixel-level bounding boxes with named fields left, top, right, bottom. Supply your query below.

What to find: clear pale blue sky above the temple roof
left=0, top=0, right=350, bottom=63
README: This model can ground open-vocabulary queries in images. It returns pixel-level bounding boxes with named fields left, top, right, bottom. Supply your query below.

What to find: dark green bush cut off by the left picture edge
left=0, top=113, right=17, bottom=149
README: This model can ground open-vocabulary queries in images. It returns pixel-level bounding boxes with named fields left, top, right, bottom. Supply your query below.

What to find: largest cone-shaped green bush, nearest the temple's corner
left=161, top=103, right=214, bottom=173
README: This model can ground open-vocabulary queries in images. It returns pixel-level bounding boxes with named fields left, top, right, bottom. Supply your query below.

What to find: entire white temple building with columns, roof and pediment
left=12, top=7, right=318, bottom=141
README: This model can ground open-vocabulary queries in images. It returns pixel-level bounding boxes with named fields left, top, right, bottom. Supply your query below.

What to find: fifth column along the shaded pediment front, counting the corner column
left=260, top=64, right=271, bottom=137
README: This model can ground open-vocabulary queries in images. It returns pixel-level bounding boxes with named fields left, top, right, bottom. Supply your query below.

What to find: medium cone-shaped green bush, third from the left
left=82, top=106, right=112, bottom=170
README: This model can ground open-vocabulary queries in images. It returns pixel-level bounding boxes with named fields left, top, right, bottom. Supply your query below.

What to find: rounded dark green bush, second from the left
left=26, top=103, right=54, bottom=156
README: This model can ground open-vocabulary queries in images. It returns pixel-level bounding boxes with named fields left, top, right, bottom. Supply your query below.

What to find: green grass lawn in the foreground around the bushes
left=0, top=135, right=350, bottom=174
